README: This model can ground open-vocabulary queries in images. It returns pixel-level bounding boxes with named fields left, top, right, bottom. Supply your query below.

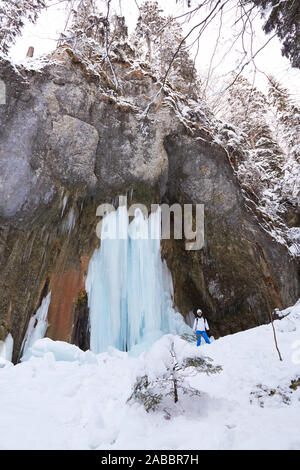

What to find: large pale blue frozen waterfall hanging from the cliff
left=86, top=200, right=188, bottom=353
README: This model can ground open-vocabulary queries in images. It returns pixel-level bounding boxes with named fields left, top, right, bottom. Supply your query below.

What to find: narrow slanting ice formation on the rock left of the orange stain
left=21, top=292, right=51, bottom=361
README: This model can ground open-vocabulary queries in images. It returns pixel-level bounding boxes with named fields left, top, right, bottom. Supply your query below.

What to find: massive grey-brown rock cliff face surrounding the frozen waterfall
left=0, top=51, right=299, bottom=361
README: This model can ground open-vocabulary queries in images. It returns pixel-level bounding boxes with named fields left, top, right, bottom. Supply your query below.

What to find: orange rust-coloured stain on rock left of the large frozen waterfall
left=47, top=256, right=89, bottom=342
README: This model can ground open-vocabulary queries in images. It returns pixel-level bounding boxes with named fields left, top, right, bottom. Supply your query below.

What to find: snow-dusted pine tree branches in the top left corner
left=0, top=0, right=46, bottom=54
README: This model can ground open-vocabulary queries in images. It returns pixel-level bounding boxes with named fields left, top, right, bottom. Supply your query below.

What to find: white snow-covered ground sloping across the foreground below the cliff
left=0, top=302, right=300, bottom=450
